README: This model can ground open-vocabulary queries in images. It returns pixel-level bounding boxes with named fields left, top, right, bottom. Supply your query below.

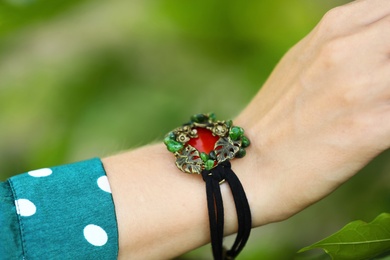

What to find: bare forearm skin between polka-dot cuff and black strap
left=102, top=144, right=209, bottom=259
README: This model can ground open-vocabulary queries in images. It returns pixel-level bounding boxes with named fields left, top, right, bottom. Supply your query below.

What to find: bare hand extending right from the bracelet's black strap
left=236, top=0, right=390, bottom=225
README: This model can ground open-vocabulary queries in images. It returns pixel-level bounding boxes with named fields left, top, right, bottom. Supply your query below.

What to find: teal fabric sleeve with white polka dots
left=0, top=159, right=118, bottom=259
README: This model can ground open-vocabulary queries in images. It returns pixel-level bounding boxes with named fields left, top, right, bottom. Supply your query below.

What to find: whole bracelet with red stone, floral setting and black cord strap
left=164, top=113, right=252, bottom=260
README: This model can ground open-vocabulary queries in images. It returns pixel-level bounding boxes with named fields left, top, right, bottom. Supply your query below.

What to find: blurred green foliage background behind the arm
left=0, top=0, right=390, bottom=259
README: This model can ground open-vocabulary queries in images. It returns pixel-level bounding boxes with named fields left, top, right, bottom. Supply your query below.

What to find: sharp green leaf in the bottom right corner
left=298, top=213, right=390, bottom=260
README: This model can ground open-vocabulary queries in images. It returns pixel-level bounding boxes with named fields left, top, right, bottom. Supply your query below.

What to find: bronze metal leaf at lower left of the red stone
left=176, top=145, right=203, bottom=173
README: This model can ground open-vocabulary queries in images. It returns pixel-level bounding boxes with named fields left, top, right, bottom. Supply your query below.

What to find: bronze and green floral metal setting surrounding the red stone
left=164, top=113, right=250, bottom=174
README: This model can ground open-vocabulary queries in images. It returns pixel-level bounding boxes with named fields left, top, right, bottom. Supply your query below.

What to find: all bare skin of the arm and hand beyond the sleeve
left=103, top=0, right=390, bottom=259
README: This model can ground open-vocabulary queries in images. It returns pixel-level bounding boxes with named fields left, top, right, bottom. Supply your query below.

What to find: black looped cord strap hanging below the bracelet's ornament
left=202, top=160, right=252, bottom=260
